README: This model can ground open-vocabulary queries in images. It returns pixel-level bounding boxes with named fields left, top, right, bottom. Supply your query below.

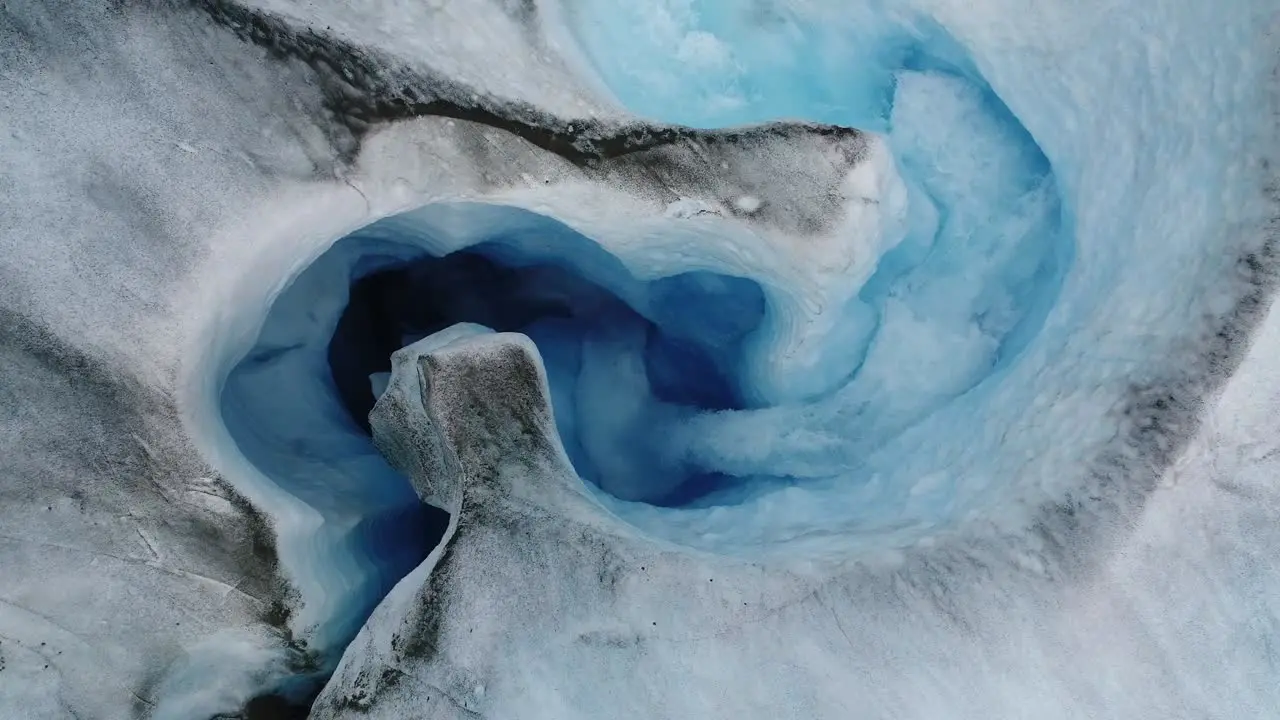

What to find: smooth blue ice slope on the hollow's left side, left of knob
left=221, top=234, right=447, bottom=650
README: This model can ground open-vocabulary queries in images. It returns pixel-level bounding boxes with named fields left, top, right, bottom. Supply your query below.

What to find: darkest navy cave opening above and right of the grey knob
left=326, top=242, right=765, bottom=507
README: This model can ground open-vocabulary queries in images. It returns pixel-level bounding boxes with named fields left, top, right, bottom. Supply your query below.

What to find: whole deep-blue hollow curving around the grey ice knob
left=221, top=204, right=765, bottom=651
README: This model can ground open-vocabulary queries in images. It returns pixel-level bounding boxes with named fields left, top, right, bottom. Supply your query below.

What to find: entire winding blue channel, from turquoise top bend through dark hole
left=223, top=6, right=1071, bottom=625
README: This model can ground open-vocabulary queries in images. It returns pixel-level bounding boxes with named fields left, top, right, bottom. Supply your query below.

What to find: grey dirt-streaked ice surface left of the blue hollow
left=0, top=3, right=363, bottom=719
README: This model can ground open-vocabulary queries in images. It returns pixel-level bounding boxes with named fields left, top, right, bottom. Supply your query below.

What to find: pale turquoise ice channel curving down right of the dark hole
left=550, top=0, right=1262, bottom=552
